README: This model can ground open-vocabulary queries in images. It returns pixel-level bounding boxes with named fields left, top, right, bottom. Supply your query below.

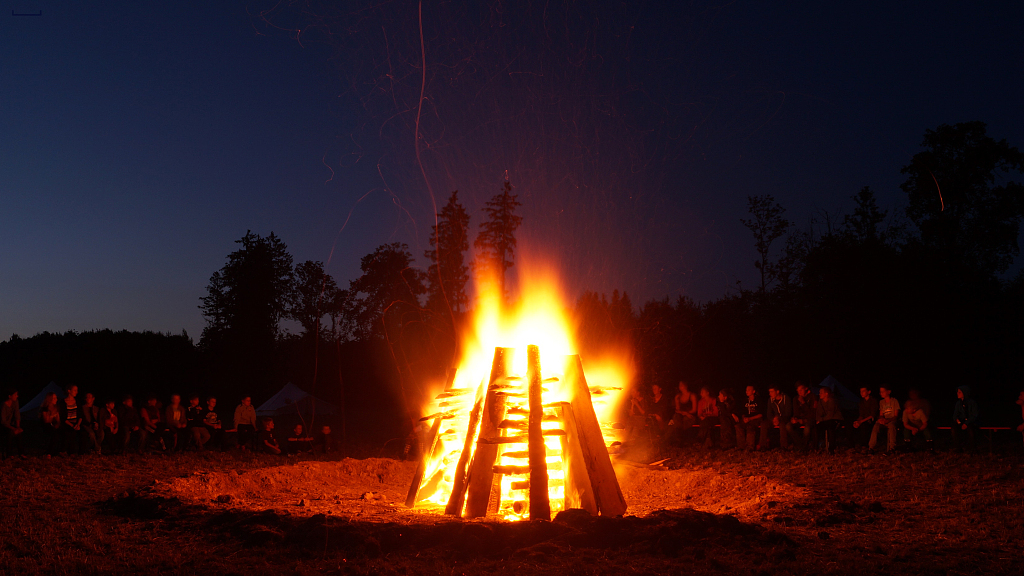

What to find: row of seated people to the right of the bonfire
left=627, top=381, right=1024, bottom=453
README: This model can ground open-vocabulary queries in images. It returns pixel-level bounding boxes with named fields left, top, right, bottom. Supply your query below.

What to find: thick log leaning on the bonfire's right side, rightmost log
left=564, top=355, right=626, bottom=517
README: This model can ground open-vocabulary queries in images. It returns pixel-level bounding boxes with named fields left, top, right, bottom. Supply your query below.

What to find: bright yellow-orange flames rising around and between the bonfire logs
left=411, top=266, right=631, bottom=520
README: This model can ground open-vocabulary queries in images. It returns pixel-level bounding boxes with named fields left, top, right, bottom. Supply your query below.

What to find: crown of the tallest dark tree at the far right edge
left=900, top=122, right=1024, bottom=276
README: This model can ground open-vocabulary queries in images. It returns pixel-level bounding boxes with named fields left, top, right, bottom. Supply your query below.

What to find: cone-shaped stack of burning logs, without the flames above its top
left=406, top=345, right=626, bottom=520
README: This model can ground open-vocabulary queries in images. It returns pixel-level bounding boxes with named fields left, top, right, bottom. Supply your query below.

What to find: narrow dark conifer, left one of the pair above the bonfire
left=424, top=191, right=469, bottom=317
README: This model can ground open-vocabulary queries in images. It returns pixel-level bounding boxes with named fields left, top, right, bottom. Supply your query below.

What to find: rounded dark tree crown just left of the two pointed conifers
left=349, top=242, right=426, bottom=338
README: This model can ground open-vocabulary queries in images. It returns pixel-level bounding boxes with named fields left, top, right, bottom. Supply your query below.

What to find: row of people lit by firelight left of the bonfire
left=0, top=385, right=338, bottom=458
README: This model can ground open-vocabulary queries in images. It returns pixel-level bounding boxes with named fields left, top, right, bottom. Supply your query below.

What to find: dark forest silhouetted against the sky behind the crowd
left=0, top=122, right=1024, bottom=439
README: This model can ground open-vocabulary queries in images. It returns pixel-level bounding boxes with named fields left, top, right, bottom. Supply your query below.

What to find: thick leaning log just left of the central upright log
left=463, top=347, right=515, bottom=518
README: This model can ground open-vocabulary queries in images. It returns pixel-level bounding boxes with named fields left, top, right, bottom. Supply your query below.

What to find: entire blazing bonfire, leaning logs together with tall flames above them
left=406, top=270, right=626, bottom=520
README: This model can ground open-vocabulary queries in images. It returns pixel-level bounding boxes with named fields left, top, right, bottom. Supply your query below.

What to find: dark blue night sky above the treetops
left=0, top=0, right=1024, bottom=339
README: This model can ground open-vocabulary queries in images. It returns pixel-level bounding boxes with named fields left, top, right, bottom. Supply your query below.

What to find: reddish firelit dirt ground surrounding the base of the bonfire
left=0, top=450, right=1024, bottom=575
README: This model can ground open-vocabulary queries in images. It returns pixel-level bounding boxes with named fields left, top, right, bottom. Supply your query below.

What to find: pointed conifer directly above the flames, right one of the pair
left=473, top=182, right=522, bottom=297
